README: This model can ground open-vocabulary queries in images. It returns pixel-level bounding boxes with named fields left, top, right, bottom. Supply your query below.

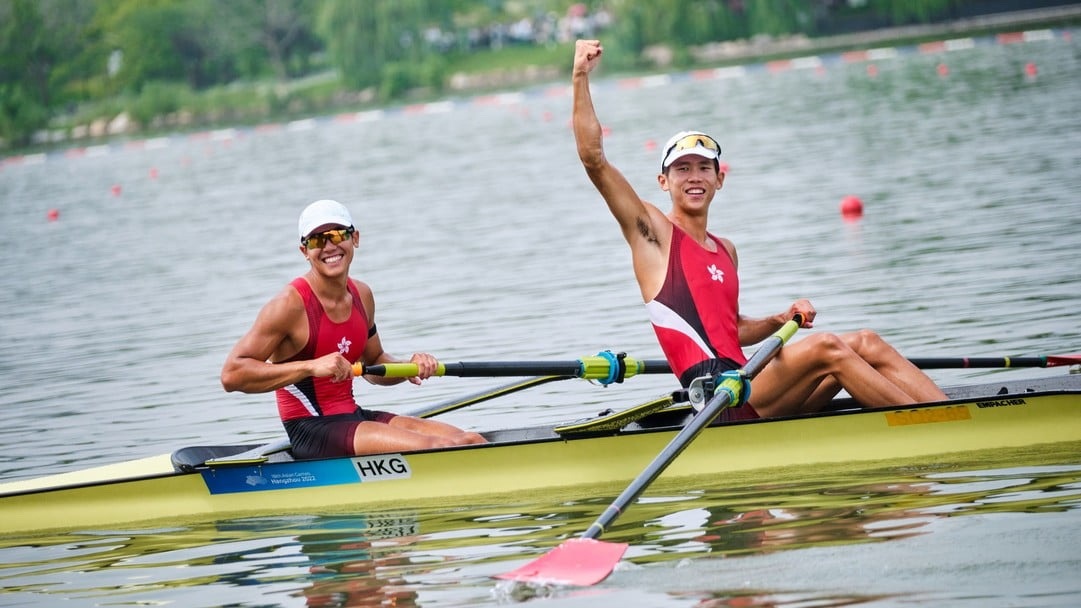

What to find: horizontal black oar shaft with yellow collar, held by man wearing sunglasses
left=352, top=351, right=669, bottom=384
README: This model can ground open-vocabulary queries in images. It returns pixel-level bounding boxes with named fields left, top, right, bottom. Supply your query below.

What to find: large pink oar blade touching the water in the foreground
left=495, top=538, right=627, bottom=586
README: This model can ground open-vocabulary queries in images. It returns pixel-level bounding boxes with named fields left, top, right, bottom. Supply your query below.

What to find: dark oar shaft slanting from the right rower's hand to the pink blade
left=582, top=315, right=803, bottom=539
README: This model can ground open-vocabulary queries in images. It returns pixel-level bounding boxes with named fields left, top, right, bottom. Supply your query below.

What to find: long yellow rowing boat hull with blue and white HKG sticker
left=0, top=379, right=1081, bottom=536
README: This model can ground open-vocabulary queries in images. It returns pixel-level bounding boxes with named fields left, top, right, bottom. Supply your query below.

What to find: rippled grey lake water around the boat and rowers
left=0, top=30, right=1081, bottom=607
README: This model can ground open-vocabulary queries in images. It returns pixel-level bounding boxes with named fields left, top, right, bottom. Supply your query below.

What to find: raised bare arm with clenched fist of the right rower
left=571, top=40, right=671, bottom=300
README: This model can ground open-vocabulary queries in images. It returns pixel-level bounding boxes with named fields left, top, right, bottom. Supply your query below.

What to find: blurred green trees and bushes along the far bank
left=0, top=0, right=980, bottom=147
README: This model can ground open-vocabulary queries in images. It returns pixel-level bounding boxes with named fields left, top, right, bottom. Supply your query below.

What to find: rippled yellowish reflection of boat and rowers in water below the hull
left=0, top=445, right=1081, bottom=607
